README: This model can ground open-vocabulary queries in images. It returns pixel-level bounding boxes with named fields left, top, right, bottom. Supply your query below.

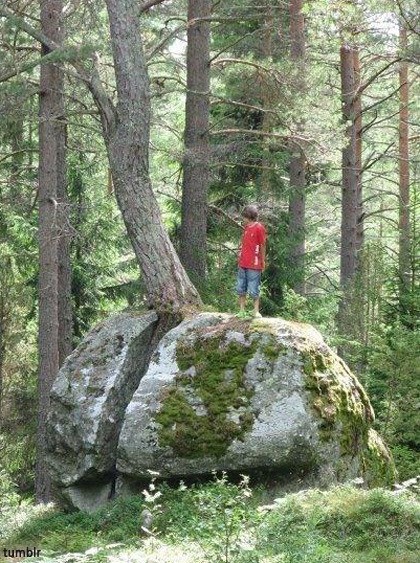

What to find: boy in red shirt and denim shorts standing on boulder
left=237, top=205, right=267, bottom=318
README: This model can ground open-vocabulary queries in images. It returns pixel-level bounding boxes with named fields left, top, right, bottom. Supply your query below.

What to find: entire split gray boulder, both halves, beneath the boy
left=48, top=313, right=394, bottom=510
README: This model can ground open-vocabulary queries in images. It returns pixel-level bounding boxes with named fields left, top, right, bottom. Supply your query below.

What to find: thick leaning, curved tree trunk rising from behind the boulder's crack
left=103, top=0, right=201, bottom=313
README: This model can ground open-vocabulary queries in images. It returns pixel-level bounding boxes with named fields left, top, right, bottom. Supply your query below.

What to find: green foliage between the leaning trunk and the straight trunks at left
left=68, top=154, right=138, bottom=342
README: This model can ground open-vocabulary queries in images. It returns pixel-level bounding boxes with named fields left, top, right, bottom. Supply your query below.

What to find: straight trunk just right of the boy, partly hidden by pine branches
left=289, top=0, right=306, bottom=295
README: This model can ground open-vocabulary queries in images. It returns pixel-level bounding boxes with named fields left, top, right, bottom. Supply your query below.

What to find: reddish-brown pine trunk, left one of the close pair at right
left=340, top=45, right=358, bottom=291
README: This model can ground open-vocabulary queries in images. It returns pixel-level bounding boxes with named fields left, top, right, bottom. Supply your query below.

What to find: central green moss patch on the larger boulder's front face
left=156, top=333, right=258, bottom=458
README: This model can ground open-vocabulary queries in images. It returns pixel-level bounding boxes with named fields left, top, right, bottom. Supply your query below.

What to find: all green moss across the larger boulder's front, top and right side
left=154, top=318, right=395, bottom=485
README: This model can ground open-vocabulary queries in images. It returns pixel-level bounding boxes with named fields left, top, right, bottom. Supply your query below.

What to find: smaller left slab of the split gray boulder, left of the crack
left=47, top=312, right=157, bottom=508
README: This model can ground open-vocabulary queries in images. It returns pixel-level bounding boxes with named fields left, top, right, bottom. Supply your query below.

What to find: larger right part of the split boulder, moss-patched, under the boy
left=117, top=313, right=395, bottom=486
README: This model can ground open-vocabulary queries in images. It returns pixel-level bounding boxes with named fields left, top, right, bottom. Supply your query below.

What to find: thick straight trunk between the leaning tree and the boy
left=180, top=0, right=212, bottom=283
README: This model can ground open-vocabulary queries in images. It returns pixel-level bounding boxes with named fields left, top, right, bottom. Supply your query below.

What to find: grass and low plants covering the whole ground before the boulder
left=0, top=476, right=420, bottom=563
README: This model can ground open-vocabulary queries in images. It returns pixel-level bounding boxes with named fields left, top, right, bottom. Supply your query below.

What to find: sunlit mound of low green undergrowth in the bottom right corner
left=256, top=487, right=420, bottom=563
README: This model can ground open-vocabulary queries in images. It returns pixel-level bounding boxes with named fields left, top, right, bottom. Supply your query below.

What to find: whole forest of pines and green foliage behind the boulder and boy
left=0, top=0, right=420, bottom=506
